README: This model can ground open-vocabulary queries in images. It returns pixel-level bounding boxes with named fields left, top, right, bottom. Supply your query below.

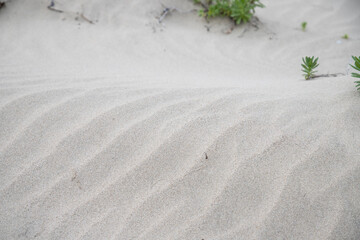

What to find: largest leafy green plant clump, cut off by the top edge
left=194, top=0, right=264, bottom=24
